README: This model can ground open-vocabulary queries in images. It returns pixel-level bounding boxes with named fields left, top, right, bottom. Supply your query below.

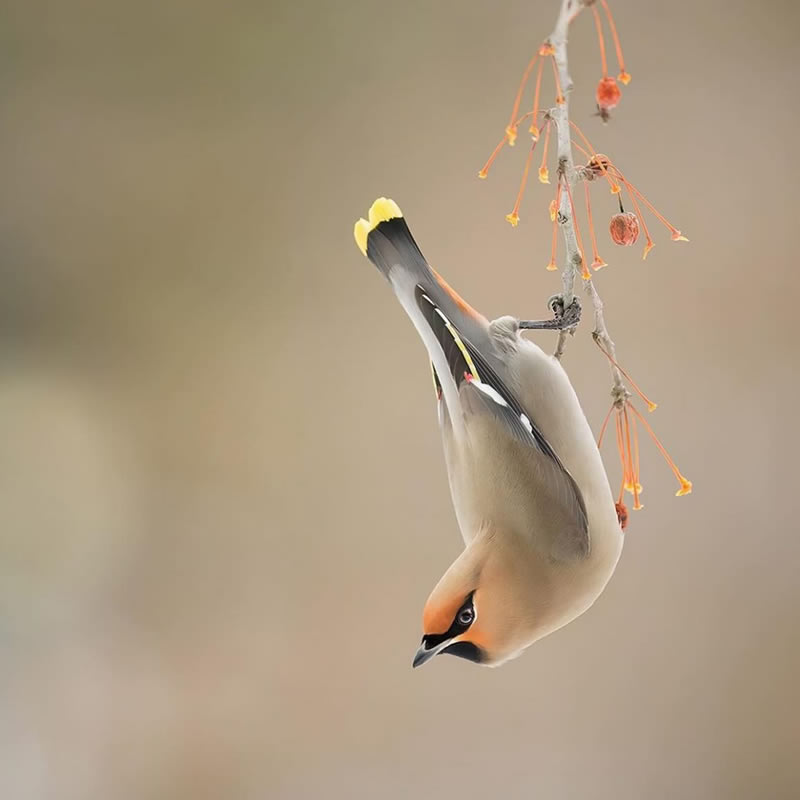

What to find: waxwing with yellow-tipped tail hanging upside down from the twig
left=354, top=197, right=624, bottom=667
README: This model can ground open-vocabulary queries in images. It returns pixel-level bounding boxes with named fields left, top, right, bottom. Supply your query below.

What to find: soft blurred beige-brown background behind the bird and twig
left=0, top=0, right=800, bottom=800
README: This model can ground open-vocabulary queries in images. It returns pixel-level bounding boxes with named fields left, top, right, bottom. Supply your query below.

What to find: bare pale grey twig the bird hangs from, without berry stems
left=548, top=0, right=629, bottom=401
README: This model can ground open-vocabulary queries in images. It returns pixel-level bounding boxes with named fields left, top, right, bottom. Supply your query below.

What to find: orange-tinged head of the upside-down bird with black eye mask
left=413, top=546, right=537, bottom=667
